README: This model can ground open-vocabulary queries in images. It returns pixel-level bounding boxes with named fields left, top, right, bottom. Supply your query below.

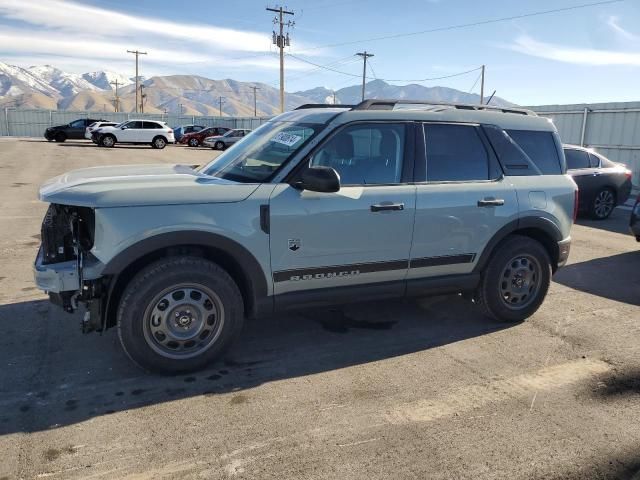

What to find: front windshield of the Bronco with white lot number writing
left=200, top=122, right=323, bottom=183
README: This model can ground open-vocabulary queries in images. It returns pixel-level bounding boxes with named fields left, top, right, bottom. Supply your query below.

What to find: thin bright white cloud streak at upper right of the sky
left=507, top=35, right=640, bottom=66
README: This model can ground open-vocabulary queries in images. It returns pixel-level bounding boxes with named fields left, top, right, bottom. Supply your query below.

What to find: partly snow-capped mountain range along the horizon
left=0, top=62, right=513, bottom=116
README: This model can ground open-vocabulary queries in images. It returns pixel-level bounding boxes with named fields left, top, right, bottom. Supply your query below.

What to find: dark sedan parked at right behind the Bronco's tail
left=563, top=145, right=632, bottom=220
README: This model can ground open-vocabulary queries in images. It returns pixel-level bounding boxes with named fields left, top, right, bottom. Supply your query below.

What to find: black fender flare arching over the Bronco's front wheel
left=102, top=230, right=273, bottom=316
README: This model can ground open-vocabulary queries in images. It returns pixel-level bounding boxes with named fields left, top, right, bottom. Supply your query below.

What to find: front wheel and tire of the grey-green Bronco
left=117, top=256, right=244, bottom=374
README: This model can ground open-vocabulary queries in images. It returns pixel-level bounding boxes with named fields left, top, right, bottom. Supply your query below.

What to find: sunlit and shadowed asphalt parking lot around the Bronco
left=0, top=139, right=640, bottom=480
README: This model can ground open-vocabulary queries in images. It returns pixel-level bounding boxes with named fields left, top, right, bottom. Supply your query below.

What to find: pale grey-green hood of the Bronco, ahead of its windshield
left=40, top=164, right=258, bottom=208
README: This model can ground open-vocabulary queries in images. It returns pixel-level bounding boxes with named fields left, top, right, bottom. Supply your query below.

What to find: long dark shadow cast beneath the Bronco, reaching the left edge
left=0, top=296, right=507, bottom=434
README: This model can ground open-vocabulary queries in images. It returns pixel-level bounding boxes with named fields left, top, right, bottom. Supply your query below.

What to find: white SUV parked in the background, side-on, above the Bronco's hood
left=91, top=120, right=175, bottom=149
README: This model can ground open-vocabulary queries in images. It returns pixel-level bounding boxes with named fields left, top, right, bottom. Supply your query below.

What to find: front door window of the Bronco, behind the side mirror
left=311, top=124, right=406, bottom=185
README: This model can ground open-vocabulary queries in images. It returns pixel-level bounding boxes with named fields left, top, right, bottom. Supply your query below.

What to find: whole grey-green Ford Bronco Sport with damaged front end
left=34, top=100, right=577, bottom=373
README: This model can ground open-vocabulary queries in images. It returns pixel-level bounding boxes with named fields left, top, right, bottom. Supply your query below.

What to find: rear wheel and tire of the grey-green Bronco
left=474, top=235, right=551, bottom=322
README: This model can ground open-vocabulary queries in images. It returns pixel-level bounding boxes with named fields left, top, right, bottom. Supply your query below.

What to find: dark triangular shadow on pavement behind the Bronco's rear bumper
left=553, top=250, right=640, bottom=305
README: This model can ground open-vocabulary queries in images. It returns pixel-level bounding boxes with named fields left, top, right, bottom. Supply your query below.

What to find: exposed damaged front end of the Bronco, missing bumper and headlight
left=34, top=204, right=104, bottom=333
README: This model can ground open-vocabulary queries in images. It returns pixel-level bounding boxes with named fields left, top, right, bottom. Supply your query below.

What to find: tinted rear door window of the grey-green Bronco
left=424, top=124, right=489, bottom=182
